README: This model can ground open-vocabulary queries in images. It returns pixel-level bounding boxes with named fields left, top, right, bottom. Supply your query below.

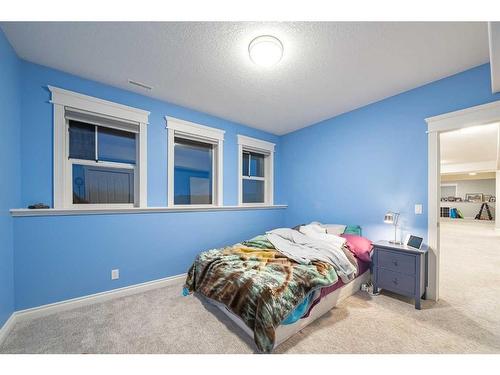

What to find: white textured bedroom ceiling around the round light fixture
left=1, top=22, right=488, bottom=134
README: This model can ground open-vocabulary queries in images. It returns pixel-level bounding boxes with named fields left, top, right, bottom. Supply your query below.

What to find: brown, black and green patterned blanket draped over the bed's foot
left=185, top=235, right=338, bottom=353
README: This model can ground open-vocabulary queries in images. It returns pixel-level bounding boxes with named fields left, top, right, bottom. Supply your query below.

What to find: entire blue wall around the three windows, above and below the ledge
left=11, top=61, right=284, bottom=310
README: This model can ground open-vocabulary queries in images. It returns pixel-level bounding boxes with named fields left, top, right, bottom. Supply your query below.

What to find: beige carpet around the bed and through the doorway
left=0, top=222, right=500, bottom=353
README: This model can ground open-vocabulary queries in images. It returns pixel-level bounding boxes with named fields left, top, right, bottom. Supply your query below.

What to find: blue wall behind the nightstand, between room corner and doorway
left=281, top=64, right=500, bottom=240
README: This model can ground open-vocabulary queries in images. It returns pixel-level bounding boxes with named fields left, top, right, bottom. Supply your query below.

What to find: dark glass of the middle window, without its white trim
left=174, top=138, right=213, bottom=204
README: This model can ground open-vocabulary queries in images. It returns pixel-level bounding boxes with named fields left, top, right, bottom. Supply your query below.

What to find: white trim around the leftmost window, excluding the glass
left=48, top=86, right=150, bottom=210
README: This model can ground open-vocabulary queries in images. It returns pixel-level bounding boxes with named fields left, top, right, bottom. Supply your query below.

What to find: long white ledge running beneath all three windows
left=10, top=204, right=288, bottom=217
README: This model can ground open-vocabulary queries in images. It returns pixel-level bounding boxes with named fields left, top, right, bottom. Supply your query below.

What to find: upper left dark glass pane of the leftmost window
left=69, top=120, right=96, bottom=160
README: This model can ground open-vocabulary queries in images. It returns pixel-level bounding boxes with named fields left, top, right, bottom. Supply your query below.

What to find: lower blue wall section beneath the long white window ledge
left=14, top=209, right=285, bottom=310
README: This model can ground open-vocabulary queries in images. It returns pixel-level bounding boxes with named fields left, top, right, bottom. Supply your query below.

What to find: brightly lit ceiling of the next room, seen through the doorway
left=440, top=123, right=498, bottom=165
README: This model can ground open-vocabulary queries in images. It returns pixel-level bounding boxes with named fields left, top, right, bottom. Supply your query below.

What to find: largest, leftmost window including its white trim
left=49, top=87, right=149, bottom=208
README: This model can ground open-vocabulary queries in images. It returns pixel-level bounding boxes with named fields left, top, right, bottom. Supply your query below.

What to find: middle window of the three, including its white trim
left=166, top=117, right=224, bottom=206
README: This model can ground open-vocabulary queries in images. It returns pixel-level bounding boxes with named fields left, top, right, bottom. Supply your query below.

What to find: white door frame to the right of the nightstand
left=425, top=100, right=500, bottom=301
